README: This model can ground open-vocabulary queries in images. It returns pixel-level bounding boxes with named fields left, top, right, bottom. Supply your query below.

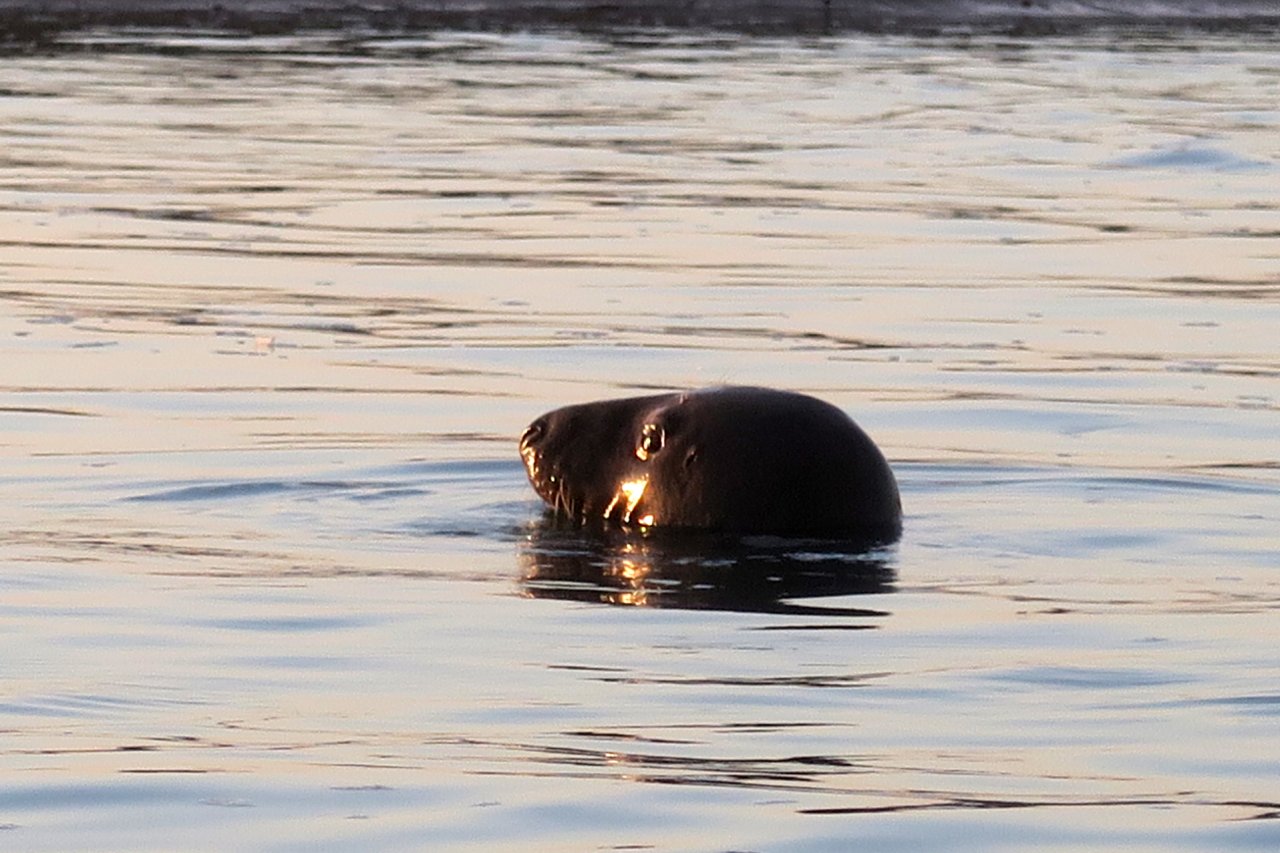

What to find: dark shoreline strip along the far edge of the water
left=0, top=0, right=1280, bottom=42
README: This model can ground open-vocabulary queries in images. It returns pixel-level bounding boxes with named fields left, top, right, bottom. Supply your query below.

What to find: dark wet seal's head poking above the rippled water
left=520, top=387, right=902, bottom=540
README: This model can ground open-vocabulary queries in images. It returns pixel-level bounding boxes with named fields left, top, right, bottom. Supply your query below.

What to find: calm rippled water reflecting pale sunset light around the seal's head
left=0, top=26, right=1280, bottom=850
